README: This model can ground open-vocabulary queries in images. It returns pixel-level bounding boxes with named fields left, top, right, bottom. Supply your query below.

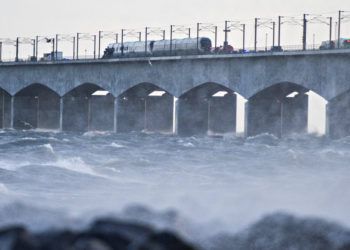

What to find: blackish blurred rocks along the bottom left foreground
left=0, top=219, right=195, bottom=250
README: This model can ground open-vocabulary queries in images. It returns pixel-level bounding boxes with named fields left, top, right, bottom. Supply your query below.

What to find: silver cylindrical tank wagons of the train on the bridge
left=102, top=37, right=212, bottom=59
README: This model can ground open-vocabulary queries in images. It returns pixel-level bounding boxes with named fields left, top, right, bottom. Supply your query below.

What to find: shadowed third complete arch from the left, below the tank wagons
left=117, top=82, right=174, bottom=133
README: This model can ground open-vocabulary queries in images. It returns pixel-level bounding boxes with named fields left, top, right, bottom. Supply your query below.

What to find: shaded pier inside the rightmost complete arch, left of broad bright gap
left=246, top=84, right=309, bottom=137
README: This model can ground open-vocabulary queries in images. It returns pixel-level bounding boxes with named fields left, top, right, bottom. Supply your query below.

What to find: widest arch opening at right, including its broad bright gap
left=246, top=82, right=326, bottom=137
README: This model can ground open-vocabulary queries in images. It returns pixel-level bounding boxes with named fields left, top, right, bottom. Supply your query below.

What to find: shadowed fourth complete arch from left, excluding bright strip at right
left=177, top=82, right=237, bottom=136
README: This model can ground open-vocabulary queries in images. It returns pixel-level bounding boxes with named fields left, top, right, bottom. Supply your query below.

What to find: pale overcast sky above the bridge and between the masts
left=0, top=0, right=350, bottom=56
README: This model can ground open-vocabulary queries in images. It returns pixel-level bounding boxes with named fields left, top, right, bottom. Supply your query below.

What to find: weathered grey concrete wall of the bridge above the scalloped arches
left=0, top=50, right=350, bottom=100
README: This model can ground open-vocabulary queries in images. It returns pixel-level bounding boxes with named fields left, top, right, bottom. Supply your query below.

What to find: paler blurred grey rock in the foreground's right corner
left=207, top=214, right=350, bottom=250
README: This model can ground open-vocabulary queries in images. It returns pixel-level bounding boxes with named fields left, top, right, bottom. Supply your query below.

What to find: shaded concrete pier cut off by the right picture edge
left=326, top=92, right=350, bottom=139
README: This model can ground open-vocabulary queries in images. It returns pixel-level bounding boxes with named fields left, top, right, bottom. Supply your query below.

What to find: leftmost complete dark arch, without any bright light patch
left=13, top=83, right=60, bottom=129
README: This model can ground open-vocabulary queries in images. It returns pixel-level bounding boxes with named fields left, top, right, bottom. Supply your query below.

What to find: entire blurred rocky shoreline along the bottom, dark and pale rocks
left=0, top=213, right=350, bottom=250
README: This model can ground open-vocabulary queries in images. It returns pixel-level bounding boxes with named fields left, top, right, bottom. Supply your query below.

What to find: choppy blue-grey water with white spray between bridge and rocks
left=0, top=131, right=350, bottom=248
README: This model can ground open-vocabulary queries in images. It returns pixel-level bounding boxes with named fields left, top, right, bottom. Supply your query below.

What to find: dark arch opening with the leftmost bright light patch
left=62, top=83, right=115, bottom=131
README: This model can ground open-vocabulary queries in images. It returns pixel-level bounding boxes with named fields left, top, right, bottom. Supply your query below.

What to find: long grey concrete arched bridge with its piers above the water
left=0, top=50, right=350, bottom=137
